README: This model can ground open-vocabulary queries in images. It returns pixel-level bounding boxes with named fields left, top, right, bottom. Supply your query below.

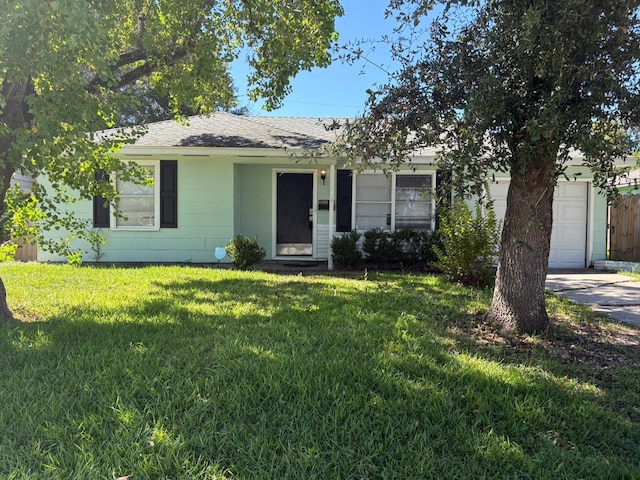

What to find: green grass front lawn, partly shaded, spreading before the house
left=0, top=264, right=640, bottom=480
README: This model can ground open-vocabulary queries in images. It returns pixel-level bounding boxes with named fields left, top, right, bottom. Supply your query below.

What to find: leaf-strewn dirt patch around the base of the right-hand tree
left=448, top=314, right=640, bottom=421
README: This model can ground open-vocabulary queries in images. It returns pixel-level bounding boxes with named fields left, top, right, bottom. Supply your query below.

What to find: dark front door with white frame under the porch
left=276, top=173, right=313, bottom=255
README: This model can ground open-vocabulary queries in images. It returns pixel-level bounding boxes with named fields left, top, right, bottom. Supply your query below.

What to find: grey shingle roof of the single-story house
left=122, top=113, right=348, bottom=148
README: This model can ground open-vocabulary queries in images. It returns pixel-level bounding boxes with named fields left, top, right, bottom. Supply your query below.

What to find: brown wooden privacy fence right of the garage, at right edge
left=609, top=195, right=640, bottom=262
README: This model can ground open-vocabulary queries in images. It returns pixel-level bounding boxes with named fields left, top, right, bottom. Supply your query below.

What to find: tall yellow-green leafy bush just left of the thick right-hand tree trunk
left=435, top=200, right=500, bottom=287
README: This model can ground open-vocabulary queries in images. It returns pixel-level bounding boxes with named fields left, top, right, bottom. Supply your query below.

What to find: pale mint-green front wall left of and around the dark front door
left=38, top=154, right=330, bottom=263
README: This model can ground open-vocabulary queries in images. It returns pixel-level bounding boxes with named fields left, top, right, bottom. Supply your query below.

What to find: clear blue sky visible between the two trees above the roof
left=233, top=0, right=396, bottom=117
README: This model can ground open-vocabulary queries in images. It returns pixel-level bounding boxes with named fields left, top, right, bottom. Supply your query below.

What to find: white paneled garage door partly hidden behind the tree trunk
left=489, top=181, right=588, bottom=268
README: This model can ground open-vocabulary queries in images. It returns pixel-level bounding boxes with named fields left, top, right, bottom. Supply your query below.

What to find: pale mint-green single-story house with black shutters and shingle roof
left=37, top=113, right=607, bottom=268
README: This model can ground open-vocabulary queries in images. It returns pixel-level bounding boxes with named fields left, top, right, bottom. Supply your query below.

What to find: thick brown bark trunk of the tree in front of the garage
left=489, top=159, right=554, bottom=334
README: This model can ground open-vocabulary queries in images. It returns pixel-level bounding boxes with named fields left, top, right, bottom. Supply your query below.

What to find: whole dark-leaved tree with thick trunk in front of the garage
left=344, top=0, right=640, bottom=332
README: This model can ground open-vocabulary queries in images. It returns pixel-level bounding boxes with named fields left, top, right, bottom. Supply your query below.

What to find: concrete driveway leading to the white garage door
left=546, top=269, right=640, bottom=327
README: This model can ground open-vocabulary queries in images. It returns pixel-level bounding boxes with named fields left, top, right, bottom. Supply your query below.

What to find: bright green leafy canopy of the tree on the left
left=0, top=0, right=343, bottom=317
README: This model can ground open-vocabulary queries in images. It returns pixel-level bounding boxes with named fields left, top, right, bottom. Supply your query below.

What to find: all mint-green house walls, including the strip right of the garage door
left=33, top=149, right=607, bottom=264
